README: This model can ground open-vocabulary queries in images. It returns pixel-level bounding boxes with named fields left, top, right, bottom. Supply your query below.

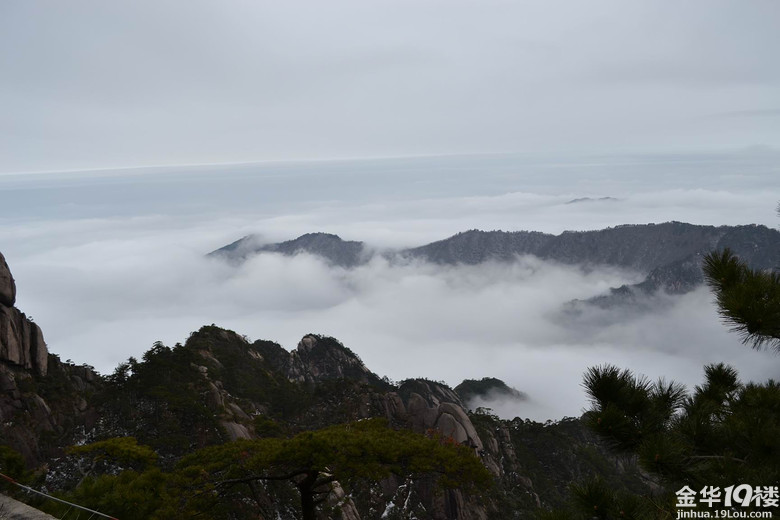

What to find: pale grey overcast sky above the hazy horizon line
left=0, top=0, right=780, bottom=172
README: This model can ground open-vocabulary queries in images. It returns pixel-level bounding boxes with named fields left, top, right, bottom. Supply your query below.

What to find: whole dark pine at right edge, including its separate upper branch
left=541, top=209, right=780, bottom=519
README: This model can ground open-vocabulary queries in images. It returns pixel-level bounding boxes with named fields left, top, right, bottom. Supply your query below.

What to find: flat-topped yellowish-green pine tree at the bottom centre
left=169, top=419, right=492, bottom=520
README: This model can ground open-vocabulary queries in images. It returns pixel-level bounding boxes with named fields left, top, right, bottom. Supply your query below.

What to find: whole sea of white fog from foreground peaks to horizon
left=0, top=149, right=780, bottom=420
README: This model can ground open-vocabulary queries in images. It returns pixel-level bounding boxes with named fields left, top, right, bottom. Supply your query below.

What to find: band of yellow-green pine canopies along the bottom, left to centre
left=39, top=419, right=493, bottom=520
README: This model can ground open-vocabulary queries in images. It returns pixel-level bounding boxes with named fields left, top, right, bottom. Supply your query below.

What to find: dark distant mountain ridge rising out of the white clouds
left=210, top=222, right=780, bottom=305
